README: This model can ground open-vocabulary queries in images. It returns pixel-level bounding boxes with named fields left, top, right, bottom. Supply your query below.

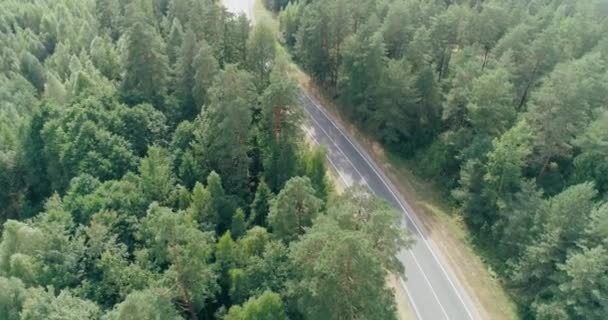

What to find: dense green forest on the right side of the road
left=265, top=0, right=608, bottom=319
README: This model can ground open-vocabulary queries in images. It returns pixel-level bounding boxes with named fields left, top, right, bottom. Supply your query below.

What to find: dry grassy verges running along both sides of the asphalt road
left=249, top=0, right=519, bottom=320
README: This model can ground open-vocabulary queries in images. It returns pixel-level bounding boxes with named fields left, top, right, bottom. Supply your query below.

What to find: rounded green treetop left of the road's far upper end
left=247, top=21, right=276, bottom=92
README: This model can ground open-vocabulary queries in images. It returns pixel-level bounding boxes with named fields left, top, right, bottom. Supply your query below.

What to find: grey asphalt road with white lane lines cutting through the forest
left=300, top=91, right=479, bottom=320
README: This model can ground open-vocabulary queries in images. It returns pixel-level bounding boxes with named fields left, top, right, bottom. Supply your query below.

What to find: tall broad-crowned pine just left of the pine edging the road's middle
left=192, top=65, right=257, bottom=199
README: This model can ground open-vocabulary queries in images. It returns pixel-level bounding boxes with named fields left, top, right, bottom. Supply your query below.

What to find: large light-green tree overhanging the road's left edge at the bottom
left=290, top=216, right=396, bottom=319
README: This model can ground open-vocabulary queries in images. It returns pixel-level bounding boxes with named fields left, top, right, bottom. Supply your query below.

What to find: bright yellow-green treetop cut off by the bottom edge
left=224, top=291, right=287, bottom=320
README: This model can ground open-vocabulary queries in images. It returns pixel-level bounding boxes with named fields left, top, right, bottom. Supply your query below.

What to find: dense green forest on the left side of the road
left=0, top=0, right=410, bottom=320
